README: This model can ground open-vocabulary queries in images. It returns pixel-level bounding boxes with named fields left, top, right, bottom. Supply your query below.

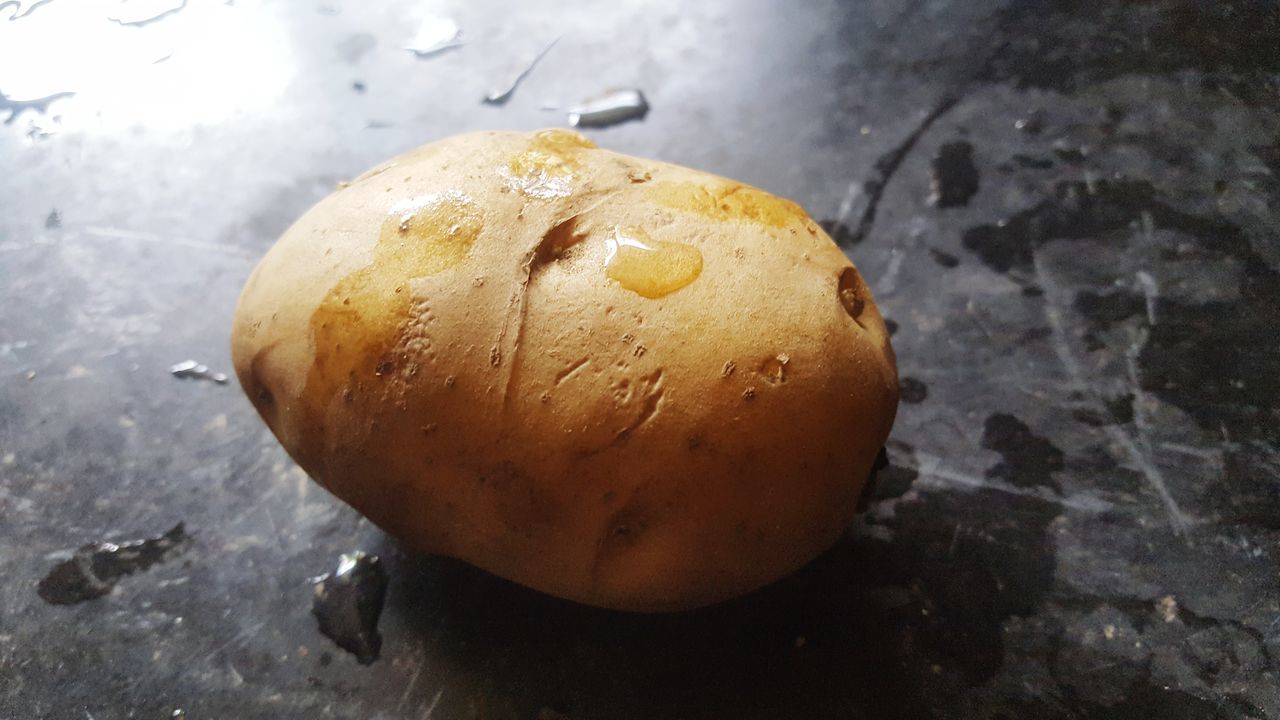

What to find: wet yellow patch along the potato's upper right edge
left=649, top=182, right=809, bottom=228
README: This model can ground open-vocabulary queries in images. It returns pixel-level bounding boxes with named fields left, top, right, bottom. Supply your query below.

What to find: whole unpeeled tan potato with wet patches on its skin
left=232, top=129, right=897, bottom=611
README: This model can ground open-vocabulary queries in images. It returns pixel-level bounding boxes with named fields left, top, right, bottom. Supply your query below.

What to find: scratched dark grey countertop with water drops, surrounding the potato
left=0, top=0, right=1280, bottom=720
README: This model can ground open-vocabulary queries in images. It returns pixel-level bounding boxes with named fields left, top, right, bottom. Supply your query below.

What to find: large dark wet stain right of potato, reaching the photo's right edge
left=963, top=179, right=1280, bottom=442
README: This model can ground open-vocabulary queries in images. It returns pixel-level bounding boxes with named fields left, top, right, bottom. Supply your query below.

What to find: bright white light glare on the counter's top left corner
left=0, top=0, right=296, bottom=132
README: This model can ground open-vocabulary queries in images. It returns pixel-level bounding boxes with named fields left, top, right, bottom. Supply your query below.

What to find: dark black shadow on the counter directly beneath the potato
left=363, top=468, right=1055, bottom=719
